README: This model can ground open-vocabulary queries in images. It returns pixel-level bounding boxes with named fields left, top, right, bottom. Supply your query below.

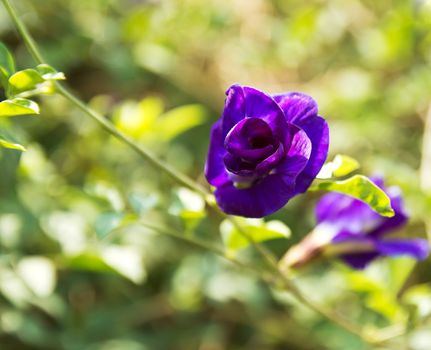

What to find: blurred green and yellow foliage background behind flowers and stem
left=0, top=0, right=431, bottom=350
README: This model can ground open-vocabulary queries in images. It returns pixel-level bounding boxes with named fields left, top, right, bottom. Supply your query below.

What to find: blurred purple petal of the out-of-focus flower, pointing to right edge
left=376, top=239, right=429, bottom=260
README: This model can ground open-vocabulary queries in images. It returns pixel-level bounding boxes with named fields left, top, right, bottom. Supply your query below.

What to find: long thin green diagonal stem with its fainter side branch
left=2, top=0, right=394, bottom=343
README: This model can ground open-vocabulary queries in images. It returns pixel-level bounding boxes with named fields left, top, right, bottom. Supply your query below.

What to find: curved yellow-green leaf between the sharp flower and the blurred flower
left=310, top=175, right=395, bottom=217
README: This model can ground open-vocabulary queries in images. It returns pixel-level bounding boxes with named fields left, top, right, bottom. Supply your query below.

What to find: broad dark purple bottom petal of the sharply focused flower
left=214, top=174, right=294, bottom=218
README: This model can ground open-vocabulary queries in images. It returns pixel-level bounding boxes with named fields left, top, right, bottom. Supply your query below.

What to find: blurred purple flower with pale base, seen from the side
left=281, top=178, right=429, bottom=269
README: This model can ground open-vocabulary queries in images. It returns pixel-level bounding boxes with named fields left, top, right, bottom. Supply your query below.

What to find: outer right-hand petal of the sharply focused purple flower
left=296, top=116, right=329, bottom=193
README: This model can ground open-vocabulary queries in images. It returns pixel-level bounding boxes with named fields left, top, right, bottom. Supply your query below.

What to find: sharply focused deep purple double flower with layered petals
left=205, top=85, right=329, bottom=218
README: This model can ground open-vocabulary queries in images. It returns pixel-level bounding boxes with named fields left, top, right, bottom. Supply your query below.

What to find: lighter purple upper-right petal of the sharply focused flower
left=272, top=92, right=317, bottom=126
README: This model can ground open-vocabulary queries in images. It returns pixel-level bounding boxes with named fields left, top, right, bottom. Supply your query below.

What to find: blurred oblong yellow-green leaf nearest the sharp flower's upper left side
left=156, top=105, right=206, bottom=140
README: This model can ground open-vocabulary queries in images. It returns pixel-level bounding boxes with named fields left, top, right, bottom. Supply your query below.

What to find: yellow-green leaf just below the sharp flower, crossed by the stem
left=220, top=219, right=290, bottom=250
